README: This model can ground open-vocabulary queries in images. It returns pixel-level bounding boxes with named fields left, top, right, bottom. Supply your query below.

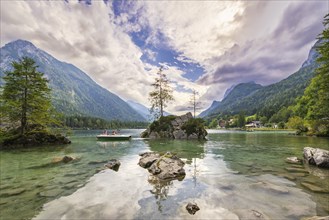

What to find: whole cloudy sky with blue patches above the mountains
left=0, top=0, right=329, bottom=114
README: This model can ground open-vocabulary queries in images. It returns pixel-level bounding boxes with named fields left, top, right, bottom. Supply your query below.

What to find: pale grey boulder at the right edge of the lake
left=304, top=147, right=329, bottom=168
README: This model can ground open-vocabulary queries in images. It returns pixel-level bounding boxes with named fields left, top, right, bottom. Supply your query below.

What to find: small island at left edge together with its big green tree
left=0, top=57, right=71, bottom=148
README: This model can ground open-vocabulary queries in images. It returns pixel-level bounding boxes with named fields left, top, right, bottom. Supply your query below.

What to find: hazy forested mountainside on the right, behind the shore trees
left=203, top=40, right=321, bottom=118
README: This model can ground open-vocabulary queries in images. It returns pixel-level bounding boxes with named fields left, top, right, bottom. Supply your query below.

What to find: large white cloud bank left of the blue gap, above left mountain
left=1, top=1, right=152, bottom=107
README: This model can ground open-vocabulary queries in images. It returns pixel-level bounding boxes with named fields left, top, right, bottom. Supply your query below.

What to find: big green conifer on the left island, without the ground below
left=1, top=57, right=51, bottom=135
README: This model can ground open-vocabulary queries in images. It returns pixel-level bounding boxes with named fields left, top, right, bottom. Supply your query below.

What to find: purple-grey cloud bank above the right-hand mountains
left=198, top=2, right=328, bottom=100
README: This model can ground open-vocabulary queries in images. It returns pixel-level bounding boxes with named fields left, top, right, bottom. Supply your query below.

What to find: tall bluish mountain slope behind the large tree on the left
left=0, top=40, right=144, bottom=121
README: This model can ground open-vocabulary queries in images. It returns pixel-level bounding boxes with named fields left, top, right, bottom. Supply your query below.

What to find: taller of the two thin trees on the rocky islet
left=149, top=66, right=174, bottom=119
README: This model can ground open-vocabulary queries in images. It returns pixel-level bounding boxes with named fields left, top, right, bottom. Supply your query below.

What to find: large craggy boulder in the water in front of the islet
left=138, top=152, right=186, bottom=180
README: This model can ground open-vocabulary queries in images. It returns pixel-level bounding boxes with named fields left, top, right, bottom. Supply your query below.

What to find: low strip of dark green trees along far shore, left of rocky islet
left=64, top=115, right=148, bottom=129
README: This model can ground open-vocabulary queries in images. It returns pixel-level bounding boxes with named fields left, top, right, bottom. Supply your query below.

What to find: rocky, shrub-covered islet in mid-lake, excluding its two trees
left=141, top=112, right=208, bottom=140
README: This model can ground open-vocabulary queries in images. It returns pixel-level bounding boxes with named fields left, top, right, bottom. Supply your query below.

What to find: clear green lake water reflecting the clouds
left=0, top=130, right=329, bottom=220
